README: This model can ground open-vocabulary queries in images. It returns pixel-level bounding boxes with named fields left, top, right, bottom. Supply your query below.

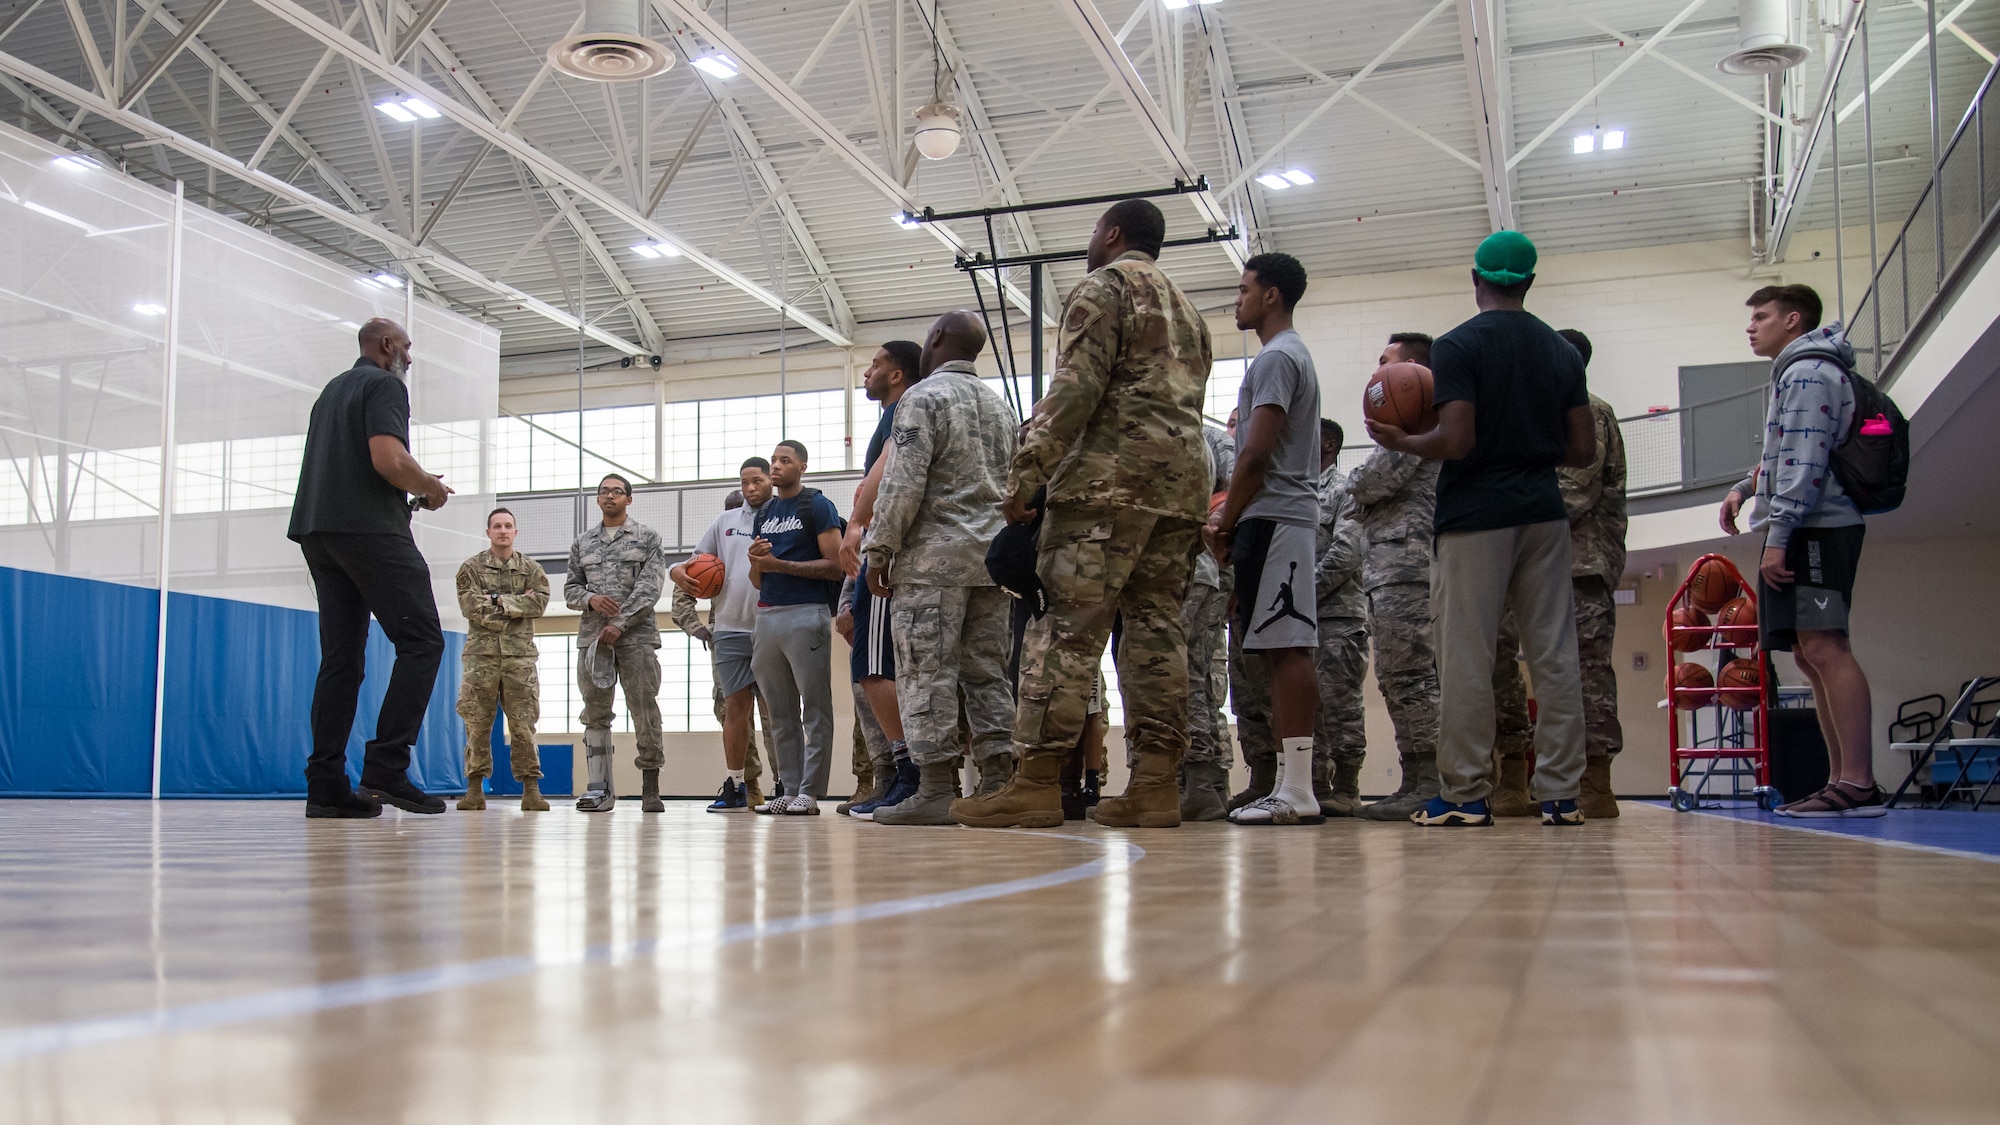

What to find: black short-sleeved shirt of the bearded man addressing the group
left=286, top=358, right=410, bottom=538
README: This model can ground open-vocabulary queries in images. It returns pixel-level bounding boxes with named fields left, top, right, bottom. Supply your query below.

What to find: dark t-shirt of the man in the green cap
left=1430, top=308, right=1590, bottom=532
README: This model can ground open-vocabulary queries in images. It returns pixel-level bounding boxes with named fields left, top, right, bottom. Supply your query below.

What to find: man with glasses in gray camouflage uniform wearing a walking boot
left=562, top=486, right=666, bottom=813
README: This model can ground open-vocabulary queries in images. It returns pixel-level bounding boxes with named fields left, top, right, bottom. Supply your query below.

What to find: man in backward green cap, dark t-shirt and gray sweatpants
left=1368, top=230, right=1596, bottom=825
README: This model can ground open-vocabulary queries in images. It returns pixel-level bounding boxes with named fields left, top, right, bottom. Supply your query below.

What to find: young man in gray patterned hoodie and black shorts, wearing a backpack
left=1722, top=284, right=1888, bottom=819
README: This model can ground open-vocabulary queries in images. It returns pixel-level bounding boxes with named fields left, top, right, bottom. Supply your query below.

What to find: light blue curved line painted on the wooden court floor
left=0, top=833, right=1146, bottom=1061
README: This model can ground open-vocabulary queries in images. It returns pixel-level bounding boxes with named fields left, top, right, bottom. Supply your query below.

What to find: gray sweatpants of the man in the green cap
left=1430, top=520, right=1584, bottom=805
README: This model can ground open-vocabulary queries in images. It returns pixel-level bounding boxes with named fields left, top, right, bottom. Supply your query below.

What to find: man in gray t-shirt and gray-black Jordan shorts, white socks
left=1208, top=254, right=1326, bottom=825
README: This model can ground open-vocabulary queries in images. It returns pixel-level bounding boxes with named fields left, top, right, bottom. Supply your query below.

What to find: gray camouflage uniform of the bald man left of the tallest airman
left=862, top=360, right=1020, bottom=767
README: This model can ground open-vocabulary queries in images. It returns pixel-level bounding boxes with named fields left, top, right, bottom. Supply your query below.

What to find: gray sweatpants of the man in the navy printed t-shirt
left=750, top=603, right=834, bottom=797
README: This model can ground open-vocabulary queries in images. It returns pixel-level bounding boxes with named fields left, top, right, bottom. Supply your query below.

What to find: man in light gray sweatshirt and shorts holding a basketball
left=666, top=456, right=770, bottom=813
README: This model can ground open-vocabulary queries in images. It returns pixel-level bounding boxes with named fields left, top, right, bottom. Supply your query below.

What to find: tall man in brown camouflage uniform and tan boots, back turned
left=954, top=200, right=1214, bottom=827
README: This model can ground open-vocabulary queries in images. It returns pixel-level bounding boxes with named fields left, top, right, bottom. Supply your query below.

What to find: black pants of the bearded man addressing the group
left=298, top=532, right=444, bottom=785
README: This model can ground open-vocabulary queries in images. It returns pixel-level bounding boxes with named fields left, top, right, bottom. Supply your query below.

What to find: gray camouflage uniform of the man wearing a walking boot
left=562, top=518, right=666, bottom=769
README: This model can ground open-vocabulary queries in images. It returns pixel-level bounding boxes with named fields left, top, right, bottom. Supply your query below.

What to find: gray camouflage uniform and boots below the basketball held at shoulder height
left=1348, top=448, right=1440, bottom=821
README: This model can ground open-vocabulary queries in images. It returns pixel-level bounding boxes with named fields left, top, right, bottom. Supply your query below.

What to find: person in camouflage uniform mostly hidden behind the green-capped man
left=1488, top=394, right=1626, bottom=808
